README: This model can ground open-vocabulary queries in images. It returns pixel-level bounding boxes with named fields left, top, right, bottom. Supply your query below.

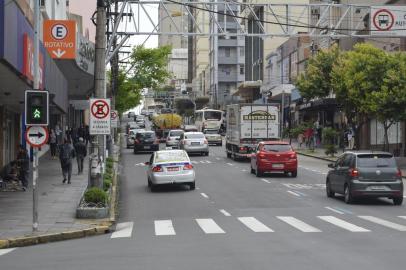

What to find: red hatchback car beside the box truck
left=251, top=141, right=297, bottom=177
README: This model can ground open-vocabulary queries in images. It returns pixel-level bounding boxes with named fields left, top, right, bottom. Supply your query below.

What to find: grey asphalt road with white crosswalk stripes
left=0, top=129, right=406, bottom=270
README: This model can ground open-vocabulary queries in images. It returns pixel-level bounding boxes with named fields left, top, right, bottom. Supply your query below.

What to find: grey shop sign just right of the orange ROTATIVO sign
left=76, top=35, right=96, bottom=74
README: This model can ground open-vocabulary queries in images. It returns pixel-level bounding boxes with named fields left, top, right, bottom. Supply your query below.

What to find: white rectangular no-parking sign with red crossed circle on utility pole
left=89, top=98, right=110, bottom=135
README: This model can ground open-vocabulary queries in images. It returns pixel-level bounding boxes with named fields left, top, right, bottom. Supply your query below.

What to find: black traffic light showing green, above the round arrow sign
left=25, top=90, right=49, bottom=126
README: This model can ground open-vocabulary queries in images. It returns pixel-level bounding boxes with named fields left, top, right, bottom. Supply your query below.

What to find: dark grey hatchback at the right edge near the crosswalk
left=326, top=151, right=403, bottom=205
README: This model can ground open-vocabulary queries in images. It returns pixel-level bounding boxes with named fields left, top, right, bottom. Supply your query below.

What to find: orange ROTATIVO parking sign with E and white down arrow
left=43, top=20, right=76, bottom=59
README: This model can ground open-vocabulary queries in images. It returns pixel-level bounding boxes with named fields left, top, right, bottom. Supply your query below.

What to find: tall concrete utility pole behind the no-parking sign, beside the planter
left=89, top=0, right=106, bottom=187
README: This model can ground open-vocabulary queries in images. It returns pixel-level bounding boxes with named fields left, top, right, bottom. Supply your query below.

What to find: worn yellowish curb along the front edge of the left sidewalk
left=0, top=226, right=110, bottom=249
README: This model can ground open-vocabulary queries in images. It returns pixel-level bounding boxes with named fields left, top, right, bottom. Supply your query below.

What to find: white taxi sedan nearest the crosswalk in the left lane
left=145, top=150, right=196, bottom=191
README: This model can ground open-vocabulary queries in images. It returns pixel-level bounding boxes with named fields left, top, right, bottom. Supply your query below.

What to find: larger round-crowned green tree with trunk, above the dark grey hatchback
left=332, top=44, right=391, bottom=150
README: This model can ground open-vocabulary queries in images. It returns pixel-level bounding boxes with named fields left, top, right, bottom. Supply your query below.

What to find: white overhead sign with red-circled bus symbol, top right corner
left=370, top=6, right=406, bottom=36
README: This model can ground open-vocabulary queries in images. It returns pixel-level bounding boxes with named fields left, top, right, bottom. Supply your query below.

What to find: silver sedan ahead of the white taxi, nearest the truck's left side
left=179, top=132, right=209, bottom=156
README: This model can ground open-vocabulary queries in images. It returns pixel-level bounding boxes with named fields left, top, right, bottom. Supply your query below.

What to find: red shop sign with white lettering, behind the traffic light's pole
left=22, top=33, right=44, bottom=89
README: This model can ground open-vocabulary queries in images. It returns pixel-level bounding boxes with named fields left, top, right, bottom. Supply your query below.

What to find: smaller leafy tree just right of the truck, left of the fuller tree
left=296, top=46, right=340, bottom=100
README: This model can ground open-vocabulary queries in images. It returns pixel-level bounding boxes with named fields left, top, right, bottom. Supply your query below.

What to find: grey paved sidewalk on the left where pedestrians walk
left=0, top=153, right=94, bottom=239
